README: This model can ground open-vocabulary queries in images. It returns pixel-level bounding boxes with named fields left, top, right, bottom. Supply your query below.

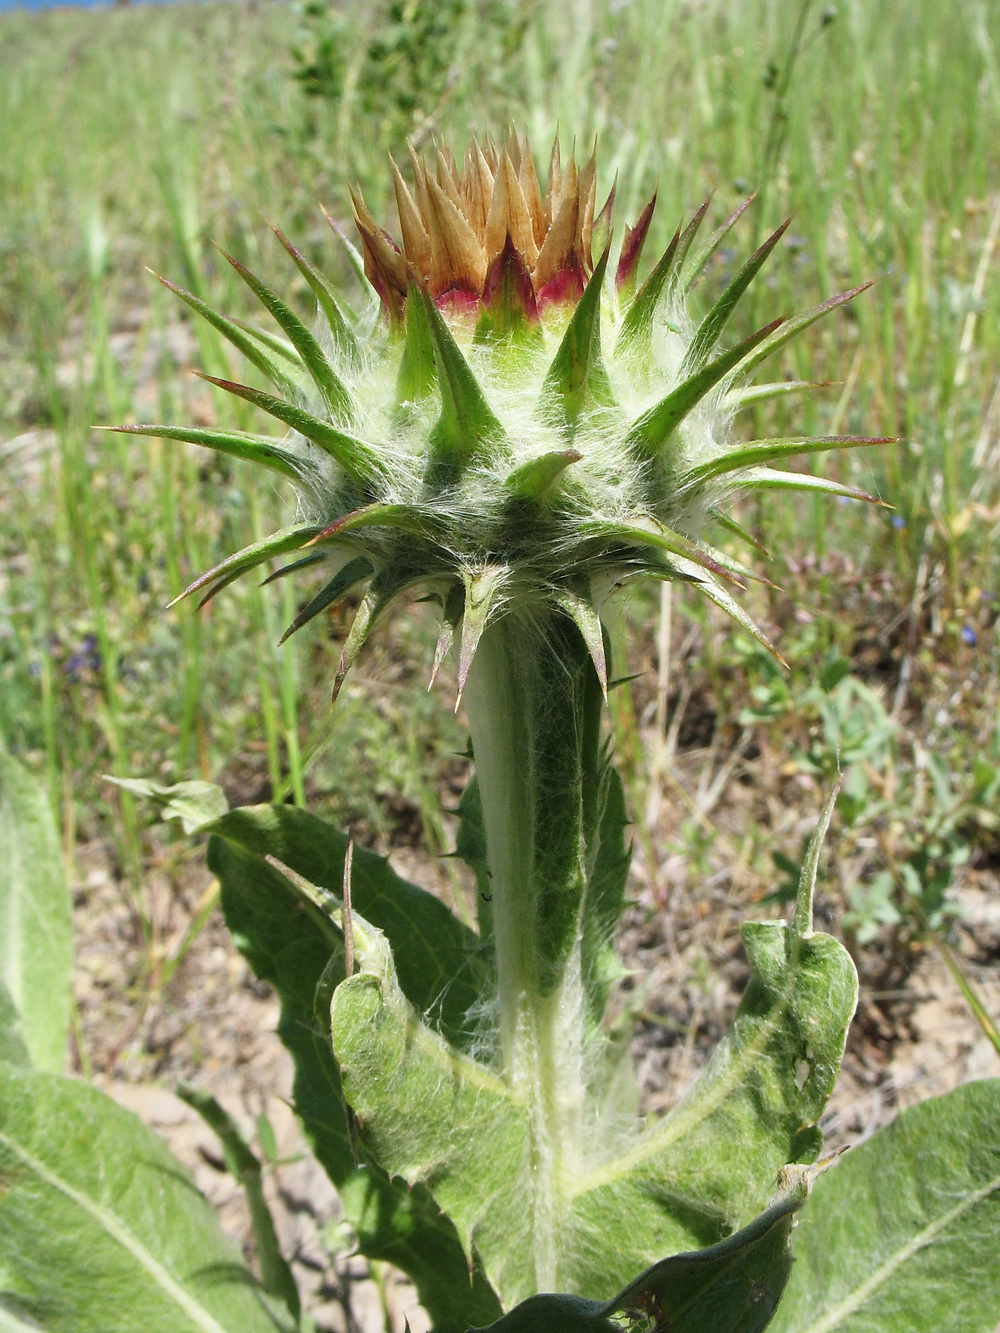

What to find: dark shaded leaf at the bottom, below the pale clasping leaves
left=469, top=1168, right=815, bottom=1333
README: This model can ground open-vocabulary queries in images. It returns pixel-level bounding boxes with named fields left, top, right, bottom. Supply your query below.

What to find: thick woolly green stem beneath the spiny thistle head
left=465, top=615, right=601, bottom=1290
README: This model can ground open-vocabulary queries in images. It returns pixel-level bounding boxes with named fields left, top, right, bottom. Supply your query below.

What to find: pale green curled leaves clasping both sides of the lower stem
left=332, top=794, right=857, bottom=1308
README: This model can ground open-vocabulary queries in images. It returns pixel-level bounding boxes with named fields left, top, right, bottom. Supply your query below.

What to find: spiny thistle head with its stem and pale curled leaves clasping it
left=102, top=136, right=896, bottom=1308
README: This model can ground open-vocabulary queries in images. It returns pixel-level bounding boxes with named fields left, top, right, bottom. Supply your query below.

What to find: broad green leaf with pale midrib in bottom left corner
left=0, top=1065, right=291, bottom=1333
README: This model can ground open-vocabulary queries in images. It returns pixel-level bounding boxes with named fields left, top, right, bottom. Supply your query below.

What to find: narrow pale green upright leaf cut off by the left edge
left=0, top=750, right=73, bottom=1072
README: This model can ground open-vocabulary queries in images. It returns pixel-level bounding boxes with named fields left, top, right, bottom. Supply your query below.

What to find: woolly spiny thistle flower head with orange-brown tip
left=117, top=137, right=876, bottom=693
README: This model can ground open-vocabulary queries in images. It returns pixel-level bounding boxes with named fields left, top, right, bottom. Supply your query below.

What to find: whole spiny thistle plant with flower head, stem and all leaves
left=0, top=139, right=1000, bottom=1333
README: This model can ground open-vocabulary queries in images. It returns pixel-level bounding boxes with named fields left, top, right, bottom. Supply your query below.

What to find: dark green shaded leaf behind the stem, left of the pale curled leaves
left=208, top=821, right=500, bottom=1333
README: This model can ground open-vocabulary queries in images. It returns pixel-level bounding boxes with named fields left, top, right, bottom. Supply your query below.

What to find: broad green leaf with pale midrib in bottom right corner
left=772, top=1078, right=1000, bottom=1333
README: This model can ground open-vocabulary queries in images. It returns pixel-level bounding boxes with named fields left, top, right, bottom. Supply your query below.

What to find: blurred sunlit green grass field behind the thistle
left=0, top=0, right=1000, bottom=965
